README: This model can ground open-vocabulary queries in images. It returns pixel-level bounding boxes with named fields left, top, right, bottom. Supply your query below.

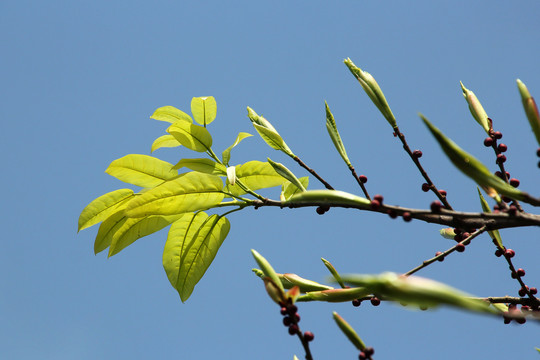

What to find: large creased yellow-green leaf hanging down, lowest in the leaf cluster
left=163, top=212, right=230, bottom=302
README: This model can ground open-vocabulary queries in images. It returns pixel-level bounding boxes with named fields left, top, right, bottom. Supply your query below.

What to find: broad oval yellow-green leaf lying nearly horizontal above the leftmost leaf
left=105, top=154, right=178, bottom=187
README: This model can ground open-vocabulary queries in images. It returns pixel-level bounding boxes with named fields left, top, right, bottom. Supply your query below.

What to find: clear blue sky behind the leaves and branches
left=0, top=0, right=540, bottom=359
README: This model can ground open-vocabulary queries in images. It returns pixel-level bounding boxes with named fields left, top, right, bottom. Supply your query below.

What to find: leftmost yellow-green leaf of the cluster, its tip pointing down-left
left=77, top=189, right=134, bottom=232
